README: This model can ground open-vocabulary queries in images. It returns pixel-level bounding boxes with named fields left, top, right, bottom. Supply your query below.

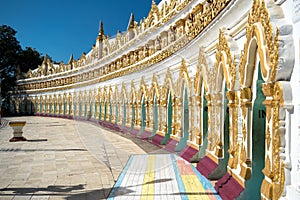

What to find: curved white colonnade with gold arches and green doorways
left=12, top=0, right=300, bottom=199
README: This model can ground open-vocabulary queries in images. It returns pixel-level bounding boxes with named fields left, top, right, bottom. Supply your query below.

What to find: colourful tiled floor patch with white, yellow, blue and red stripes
left=108, top=154, right=221, bottom=200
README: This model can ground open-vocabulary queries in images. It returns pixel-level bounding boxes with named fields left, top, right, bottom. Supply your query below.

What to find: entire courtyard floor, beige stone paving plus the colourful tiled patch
left=0, top=117, right=218, bottom=200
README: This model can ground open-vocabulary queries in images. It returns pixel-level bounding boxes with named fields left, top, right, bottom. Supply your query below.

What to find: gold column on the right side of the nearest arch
left=261, top=83, right=285, bottom=199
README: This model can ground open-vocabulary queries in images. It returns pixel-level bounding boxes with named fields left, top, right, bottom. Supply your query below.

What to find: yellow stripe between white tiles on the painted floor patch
left=141, top=155, right=156, bottom=200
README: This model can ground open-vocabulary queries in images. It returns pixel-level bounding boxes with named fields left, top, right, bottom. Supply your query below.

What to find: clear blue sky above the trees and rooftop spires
left=0, top=0, right=161, bottom=63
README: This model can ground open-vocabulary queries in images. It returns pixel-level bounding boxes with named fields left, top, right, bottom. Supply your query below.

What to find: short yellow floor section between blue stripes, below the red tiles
left=181, top=175, right=210, bottom=200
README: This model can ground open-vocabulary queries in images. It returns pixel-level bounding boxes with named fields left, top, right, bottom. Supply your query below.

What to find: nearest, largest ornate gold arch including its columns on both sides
left=239, top=0, right=285, bottom=199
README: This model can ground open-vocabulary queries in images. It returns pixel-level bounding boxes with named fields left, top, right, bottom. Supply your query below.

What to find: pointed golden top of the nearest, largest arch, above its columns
left=240, top=0, right=279, bottom=88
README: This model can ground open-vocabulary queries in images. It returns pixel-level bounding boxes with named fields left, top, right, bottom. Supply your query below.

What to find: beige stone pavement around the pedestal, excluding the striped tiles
left=0, top=117, right=165, bottom=200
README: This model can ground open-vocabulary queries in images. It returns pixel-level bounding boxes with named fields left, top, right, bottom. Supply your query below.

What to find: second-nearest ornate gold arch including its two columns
left=212, top=29, right=238, bottom=161
